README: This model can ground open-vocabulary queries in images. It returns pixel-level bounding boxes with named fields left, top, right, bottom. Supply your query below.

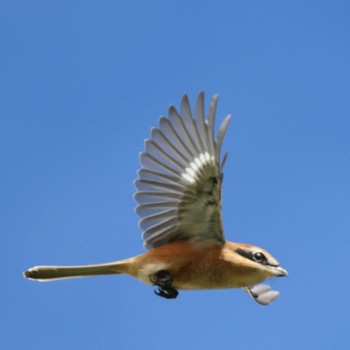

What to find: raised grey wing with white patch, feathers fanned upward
left=135, top=92, right=230, bottom=249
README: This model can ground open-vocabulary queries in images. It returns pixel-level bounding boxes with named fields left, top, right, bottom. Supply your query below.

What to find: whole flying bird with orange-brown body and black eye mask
left=24, top=91, right=288, bottom=305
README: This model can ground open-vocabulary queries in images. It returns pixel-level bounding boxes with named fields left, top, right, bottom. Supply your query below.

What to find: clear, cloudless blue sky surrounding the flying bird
left=0, top=0, right=350, bottom=350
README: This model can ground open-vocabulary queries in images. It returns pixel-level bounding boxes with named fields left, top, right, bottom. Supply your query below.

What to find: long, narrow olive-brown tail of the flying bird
left=23, top=259, right=132, bottom=281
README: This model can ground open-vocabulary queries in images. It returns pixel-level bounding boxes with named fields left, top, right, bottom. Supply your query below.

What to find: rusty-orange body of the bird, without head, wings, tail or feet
left=134, top=242, right=259, bottom=290
